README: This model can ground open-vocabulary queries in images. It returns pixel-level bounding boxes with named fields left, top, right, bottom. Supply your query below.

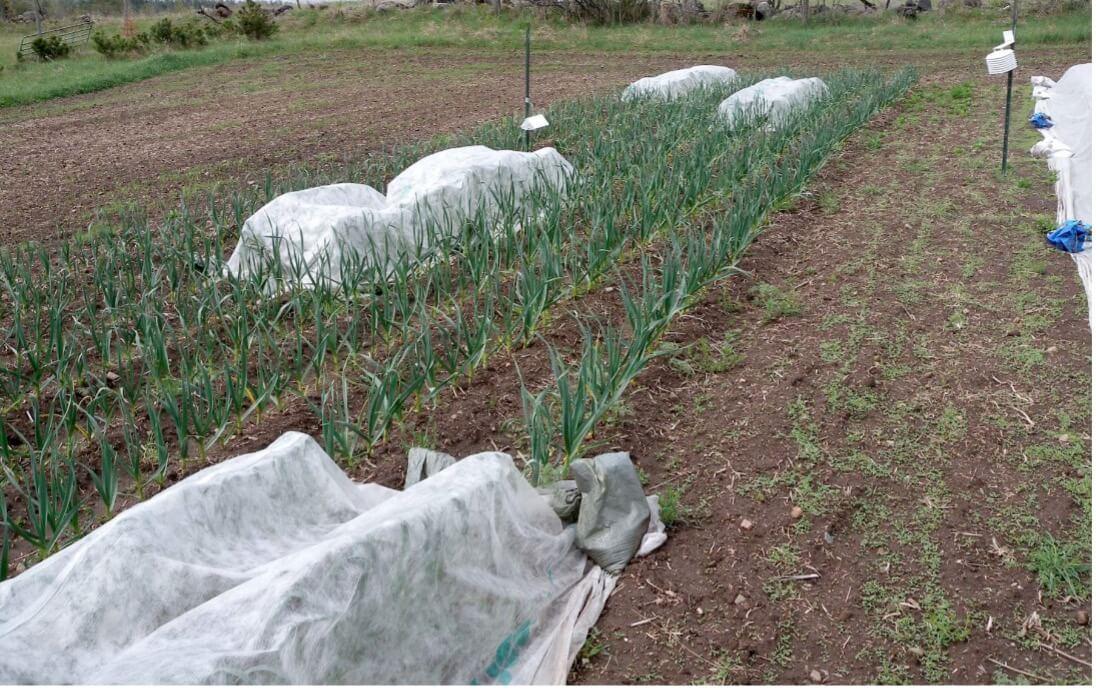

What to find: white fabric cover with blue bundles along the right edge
left=1031, top=62, right=1094, bottom=327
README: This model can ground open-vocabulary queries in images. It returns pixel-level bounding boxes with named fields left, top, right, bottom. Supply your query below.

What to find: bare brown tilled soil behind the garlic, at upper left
left=0, top=51, right=727, bottom=242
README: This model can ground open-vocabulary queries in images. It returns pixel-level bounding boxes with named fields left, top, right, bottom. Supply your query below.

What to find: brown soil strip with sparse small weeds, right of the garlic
left=573, top=63, right=1092, bottom=683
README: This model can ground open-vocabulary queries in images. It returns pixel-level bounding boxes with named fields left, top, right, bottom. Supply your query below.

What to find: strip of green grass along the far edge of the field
left=0, top=5, right=1092, bottom=107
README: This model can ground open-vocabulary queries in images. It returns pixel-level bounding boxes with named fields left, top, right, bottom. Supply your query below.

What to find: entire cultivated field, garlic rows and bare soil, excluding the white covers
left=0, top=4, right=1092, bottom=683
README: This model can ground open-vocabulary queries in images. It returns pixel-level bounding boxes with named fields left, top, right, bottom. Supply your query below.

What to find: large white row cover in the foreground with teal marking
left=0, top=433, right=664, bottom=685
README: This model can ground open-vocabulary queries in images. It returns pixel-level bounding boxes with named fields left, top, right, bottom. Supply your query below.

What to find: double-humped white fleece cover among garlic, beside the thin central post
left=226, top=146, right=573, bottom=286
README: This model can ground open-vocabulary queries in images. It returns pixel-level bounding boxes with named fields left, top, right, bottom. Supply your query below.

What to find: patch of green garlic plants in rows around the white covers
left=0, top=66, right=912, bottom=578
